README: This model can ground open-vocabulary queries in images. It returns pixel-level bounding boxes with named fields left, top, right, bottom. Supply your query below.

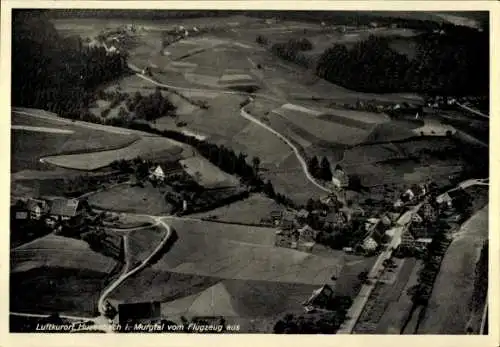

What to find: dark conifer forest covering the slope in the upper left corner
left=11, top=11, right=127, bottom=118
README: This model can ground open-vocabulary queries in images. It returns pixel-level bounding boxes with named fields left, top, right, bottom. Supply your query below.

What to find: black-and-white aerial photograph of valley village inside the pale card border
left=9, top=8, right=490, bottom=335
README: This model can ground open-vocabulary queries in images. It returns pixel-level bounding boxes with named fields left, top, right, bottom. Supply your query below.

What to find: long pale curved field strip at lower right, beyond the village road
left=418, top=206, right=488, bottom=334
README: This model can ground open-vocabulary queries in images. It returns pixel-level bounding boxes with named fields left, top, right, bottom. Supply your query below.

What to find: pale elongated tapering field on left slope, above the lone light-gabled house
left=43, top=136, right=188, bottom=171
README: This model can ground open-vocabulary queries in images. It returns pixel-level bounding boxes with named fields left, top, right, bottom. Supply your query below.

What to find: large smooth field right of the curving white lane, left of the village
left=120, top=217, right=342, bottom=285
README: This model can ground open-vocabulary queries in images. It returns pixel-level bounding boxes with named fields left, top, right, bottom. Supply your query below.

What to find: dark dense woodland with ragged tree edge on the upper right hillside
left=266, top=22, right=489, bottom=96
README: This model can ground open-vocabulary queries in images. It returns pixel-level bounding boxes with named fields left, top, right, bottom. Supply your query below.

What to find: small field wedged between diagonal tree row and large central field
left=190, top=194, right=284, bottom=224
